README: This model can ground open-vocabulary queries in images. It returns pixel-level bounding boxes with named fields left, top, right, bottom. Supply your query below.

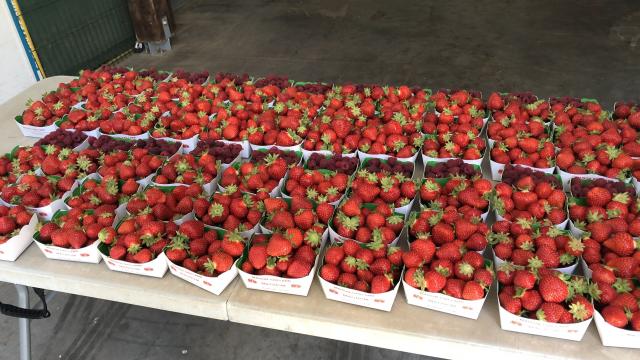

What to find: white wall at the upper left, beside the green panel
left=0, top=0, right=36, bottom=105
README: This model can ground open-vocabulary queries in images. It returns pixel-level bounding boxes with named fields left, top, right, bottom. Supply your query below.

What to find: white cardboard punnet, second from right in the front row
left=496, top=286, right=591, bottom=341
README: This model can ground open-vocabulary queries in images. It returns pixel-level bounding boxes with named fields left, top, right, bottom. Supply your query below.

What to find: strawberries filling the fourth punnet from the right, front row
left=320, top=240, right=403, bottom=294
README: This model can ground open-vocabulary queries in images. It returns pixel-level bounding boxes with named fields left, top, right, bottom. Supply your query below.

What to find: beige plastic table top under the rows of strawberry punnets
left=0, top=77, right=639, bottom=360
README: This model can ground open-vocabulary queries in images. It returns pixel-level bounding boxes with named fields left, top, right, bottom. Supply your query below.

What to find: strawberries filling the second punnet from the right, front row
left=497, top=267, right=594, bottom=324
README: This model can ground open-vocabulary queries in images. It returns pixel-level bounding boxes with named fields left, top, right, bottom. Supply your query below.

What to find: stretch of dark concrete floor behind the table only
left=122, top=0, right=640, bottom=106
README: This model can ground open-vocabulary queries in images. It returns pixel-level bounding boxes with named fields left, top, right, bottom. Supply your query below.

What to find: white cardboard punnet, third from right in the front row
left=402, top=280, right=490, bottom=320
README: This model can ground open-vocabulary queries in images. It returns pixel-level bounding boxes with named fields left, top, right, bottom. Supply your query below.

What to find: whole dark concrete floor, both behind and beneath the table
left=0, top=0, right=640, bottom=360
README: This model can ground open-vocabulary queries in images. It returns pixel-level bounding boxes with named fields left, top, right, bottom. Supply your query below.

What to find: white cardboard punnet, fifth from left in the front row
left=236, top=231, right=327, bottom=296
